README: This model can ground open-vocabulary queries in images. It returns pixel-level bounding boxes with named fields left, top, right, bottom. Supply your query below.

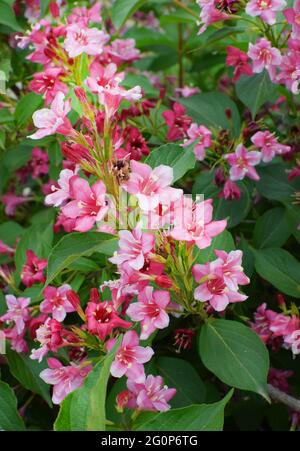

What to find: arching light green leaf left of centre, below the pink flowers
left=46, top=232, right=118, bottom=285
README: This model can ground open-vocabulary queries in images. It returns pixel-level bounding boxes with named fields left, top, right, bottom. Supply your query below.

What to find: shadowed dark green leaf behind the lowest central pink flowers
left=151, top=357, right=206, bottom=408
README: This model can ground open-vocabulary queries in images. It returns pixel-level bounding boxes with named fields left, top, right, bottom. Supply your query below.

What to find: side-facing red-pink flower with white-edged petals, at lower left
left=30, top=318, right=63, bottom=362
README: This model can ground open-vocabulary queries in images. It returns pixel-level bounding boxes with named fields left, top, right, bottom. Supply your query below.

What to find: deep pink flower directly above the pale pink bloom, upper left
left=28, top=67, right=69, bottom=105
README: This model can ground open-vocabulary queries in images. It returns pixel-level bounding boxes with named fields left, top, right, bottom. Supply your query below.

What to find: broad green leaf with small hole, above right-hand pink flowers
left=178, top=92, right=241, bottom=137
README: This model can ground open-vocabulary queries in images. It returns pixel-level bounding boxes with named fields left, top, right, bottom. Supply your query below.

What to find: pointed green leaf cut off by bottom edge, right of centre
left=133, top=390, right=233, bottom=432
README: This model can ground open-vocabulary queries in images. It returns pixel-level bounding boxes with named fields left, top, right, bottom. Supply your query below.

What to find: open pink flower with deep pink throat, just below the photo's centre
left=126, top=286, right=170, bottom=340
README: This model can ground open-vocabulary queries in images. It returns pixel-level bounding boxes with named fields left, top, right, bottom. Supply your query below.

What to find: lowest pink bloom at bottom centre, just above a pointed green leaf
left=127, top=374, right=176, bottom=412
